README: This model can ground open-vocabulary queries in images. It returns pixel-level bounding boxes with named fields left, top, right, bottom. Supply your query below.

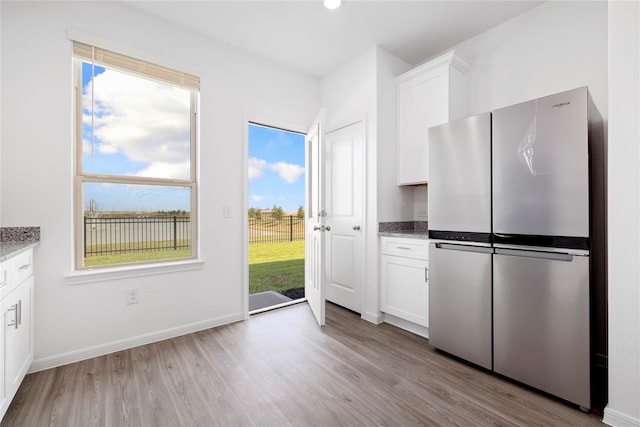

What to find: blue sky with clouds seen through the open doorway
left=248, top=124, right=304, bottom=212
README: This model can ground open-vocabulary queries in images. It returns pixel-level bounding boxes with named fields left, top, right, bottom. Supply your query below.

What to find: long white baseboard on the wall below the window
left=29, top=313, right=244, bottom=373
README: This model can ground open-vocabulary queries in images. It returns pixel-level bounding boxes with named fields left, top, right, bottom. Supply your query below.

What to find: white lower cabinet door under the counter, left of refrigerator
left=381, top=255, right=429, bottom=327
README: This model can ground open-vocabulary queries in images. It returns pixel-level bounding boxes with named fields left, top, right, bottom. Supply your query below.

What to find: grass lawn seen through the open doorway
left=249, top=240, right=304, bottom=294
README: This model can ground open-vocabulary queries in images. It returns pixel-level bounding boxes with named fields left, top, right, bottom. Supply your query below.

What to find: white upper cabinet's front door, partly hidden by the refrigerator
left=397, top=66, right=449, bottom=185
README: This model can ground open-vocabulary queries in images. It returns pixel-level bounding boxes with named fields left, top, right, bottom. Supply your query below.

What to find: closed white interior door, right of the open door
left=325, top=122, right=364, bottom=313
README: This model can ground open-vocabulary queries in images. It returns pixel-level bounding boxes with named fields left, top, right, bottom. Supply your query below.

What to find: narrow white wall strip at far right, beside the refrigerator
left=604, top=1, right=640, bottom=427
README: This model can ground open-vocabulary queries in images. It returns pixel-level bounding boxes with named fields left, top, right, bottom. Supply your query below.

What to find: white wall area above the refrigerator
left=454, top=1, right=608, bottom=121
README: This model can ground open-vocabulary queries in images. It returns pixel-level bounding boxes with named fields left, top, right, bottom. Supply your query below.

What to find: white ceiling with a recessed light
left=120, top=0, right=542, bottom=78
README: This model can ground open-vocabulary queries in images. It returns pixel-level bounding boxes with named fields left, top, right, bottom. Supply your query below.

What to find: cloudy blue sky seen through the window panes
left=82, top=63, right=191, bottom=212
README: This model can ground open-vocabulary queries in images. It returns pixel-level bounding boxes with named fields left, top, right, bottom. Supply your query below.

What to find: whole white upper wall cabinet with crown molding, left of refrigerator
left=396, top=51, right=470, bottom=185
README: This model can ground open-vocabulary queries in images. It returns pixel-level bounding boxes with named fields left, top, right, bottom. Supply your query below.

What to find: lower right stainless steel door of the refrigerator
left=493, top=249, right=591, bottom=408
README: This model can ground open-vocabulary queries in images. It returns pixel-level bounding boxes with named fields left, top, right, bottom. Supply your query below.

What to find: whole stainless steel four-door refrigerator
left=429, top=88, right=606, bottom=408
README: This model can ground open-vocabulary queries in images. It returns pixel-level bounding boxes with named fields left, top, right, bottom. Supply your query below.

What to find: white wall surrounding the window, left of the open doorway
left=1, top=1, right=320, bottom=369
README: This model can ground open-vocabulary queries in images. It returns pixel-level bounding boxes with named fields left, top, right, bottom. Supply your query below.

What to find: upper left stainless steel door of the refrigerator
left=428, top=113, right=491, bottom=242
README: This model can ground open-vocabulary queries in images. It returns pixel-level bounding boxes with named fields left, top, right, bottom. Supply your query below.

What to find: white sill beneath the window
left=64, top=259, right=204, bottom=285
